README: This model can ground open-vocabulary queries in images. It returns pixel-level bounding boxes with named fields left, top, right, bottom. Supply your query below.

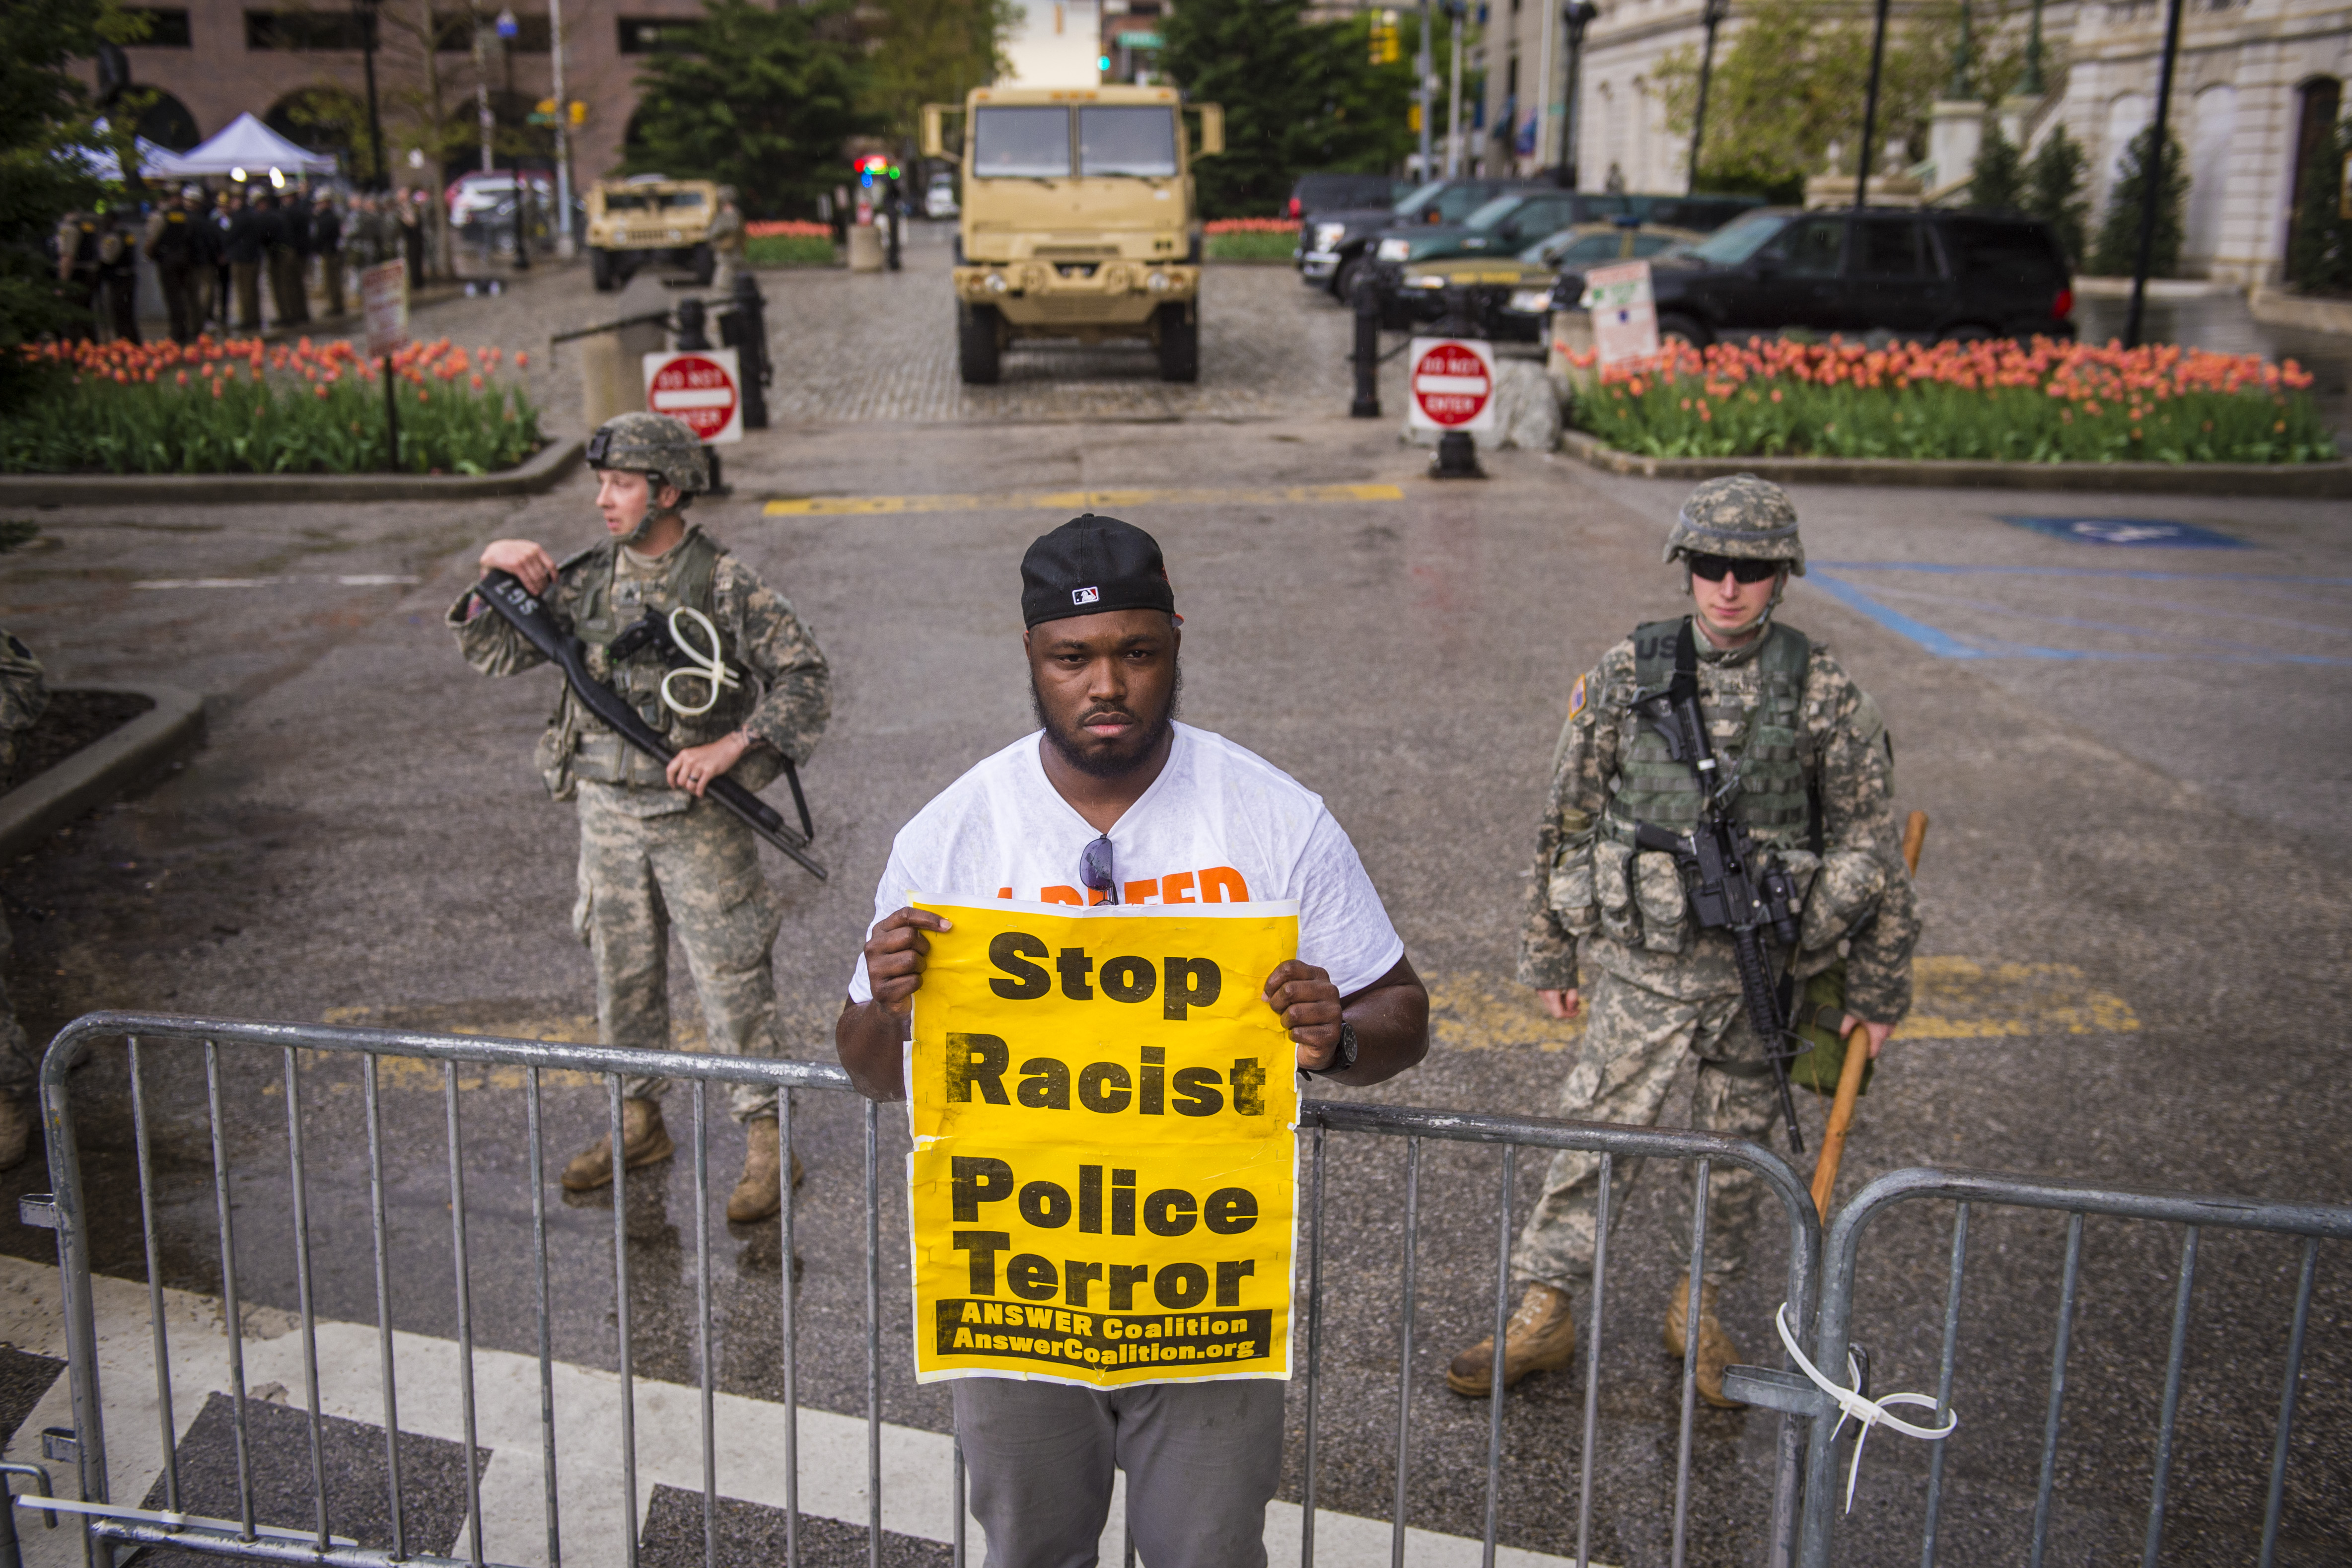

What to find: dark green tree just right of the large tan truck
left=1159, top=0, right=1430, bottom=218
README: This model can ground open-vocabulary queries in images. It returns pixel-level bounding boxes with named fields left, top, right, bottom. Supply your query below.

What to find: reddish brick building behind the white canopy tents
left=91, top=0, right=703, bottom=197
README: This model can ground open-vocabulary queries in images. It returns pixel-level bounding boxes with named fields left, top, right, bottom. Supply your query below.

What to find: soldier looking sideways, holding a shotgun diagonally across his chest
left=449, top=414, right=833, bottom=1222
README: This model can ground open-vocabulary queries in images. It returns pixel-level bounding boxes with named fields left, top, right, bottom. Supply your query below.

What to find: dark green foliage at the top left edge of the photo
left=0, top=0, right=146, bottom=414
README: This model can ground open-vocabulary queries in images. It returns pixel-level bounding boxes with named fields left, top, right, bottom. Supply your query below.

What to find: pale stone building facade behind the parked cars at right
left=1480, top=0, right=2352, bottom=282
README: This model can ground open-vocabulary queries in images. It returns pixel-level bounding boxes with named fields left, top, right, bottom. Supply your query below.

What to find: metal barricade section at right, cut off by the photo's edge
left=1785, top=1168, right=2352, bottom=1568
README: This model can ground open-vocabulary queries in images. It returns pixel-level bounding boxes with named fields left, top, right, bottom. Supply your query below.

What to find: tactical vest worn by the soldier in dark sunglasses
left=1602, top=618, right=1813, bottom=844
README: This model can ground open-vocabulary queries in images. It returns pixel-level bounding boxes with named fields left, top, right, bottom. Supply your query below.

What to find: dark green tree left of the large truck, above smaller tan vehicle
left=623, top=0, right=880, bottom=218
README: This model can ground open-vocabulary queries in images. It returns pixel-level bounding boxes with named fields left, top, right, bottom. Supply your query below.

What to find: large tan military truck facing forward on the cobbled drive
left=922, top=87, right=1225, bottom=385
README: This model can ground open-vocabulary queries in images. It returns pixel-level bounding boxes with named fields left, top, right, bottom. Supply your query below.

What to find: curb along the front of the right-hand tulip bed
left=1560, top=430, right=2352, bottom=499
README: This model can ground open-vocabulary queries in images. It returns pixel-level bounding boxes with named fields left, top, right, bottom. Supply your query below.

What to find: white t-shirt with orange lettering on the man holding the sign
left=849, top=724, right=1404, bottom=1001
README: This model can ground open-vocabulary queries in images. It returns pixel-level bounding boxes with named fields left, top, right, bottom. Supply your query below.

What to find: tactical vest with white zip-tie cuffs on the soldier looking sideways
left=541, top=527, right=783, bottom=799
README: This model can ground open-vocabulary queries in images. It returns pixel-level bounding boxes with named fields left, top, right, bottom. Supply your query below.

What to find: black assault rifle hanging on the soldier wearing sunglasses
left=1635, top=621, right=1804, bottom=1154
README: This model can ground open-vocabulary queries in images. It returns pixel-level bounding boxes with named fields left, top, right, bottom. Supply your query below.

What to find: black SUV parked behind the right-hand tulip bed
left=1552, top=207, right=2074, bottom=346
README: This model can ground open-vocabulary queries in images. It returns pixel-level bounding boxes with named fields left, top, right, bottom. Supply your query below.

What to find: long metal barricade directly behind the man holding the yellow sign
left=28, top=1013, right=1820, bottom=1568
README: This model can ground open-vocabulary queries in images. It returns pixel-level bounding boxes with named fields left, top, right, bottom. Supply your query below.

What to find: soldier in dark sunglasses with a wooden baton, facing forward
left=1446, top=475, right=1919, bottom=1406
